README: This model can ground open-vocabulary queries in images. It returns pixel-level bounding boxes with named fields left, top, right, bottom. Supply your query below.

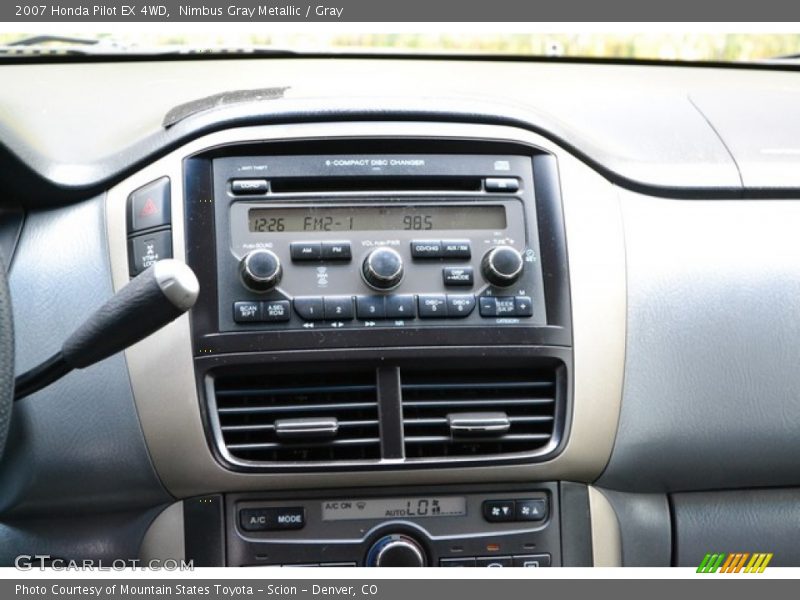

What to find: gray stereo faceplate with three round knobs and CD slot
left=213, top=155, right=547, bottom=331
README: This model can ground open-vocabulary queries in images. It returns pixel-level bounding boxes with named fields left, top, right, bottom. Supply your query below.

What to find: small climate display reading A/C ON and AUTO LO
left=322, top=496, right=467, bottom=521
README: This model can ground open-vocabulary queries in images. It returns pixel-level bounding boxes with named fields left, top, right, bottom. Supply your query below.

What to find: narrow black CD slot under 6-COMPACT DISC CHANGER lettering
left=270, top=176, right=483, bottom=194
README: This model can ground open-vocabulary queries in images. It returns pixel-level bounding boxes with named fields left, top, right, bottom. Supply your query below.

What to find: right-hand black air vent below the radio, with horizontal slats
left=401, top=368, right=558, bottom=460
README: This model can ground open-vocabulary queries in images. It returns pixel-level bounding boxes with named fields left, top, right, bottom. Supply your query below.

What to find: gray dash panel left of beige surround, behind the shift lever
left=0, top=196, right=170, bottom=516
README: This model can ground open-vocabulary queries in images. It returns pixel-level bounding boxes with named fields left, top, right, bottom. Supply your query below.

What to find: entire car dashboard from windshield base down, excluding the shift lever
left=0, top=57, right=800, bottom=567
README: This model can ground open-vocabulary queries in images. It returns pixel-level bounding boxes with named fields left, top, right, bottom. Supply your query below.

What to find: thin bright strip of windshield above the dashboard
left=0, top=30, right=800, bottom=62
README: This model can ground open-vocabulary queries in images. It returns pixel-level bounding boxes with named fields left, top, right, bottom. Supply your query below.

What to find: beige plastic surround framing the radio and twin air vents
left=106, top=122, right=626, bottom=498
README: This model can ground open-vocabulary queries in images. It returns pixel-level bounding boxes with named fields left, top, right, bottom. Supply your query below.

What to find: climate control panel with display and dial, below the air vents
left=225, top=483, right=561, bottom=568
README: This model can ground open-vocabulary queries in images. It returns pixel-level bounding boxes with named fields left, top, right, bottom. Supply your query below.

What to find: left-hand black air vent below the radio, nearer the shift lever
left=214, top=371, right=380, bottom=462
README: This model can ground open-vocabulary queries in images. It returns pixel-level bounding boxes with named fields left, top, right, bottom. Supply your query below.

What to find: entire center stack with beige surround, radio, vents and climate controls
left=108, top=123, right=624, bottom=567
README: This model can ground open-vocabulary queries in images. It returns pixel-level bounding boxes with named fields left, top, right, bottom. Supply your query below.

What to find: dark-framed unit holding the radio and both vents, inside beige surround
left=179, top=140, right=571, bottom=470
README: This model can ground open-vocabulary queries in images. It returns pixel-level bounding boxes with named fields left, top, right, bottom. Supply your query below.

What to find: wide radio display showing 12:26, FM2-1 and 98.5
left=248, top=205, right=506, bottom=233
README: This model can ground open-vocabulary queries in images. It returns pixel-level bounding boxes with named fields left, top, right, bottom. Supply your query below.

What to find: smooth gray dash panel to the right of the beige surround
left=600, top=191, right=800, bottom=493
